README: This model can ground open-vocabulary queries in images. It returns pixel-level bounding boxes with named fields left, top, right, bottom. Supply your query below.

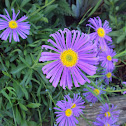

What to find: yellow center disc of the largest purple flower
left=60, top=49, right=78, bottom=67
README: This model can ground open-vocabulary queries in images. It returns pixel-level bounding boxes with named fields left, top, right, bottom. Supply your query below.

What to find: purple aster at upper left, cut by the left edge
left=0, top=9, right=30, bottom=42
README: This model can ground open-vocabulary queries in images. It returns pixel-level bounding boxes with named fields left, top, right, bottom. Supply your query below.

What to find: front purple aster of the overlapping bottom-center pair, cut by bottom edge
left=54, top=100, right=79, bottom=126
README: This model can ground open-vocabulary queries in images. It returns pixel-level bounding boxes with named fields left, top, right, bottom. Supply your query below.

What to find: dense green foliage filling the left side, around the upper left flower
left=0, top=0, right=68, bottom=126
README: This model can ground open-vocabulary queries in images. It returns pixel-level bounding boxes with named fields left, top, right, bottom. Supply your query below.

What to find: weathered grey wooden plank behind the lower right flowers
left=79, top=96, right=126, bottom=126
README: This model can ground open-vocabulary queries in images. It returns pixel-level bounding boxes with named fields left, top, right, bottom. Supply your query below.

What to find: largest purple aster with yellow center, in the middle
left=39, top=28, right=98, bottom=89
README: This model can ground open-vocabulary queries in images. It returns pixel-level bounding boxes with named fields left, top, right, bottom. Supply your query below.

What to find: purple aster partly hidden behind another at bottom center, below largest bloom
left=65, top=94, right=85, bottom=117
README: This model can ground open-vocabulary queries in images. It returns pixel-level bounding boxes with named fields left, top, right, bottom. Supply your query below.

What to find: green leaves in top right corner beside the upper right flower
left=104, top=0, right=126, bottom=59
